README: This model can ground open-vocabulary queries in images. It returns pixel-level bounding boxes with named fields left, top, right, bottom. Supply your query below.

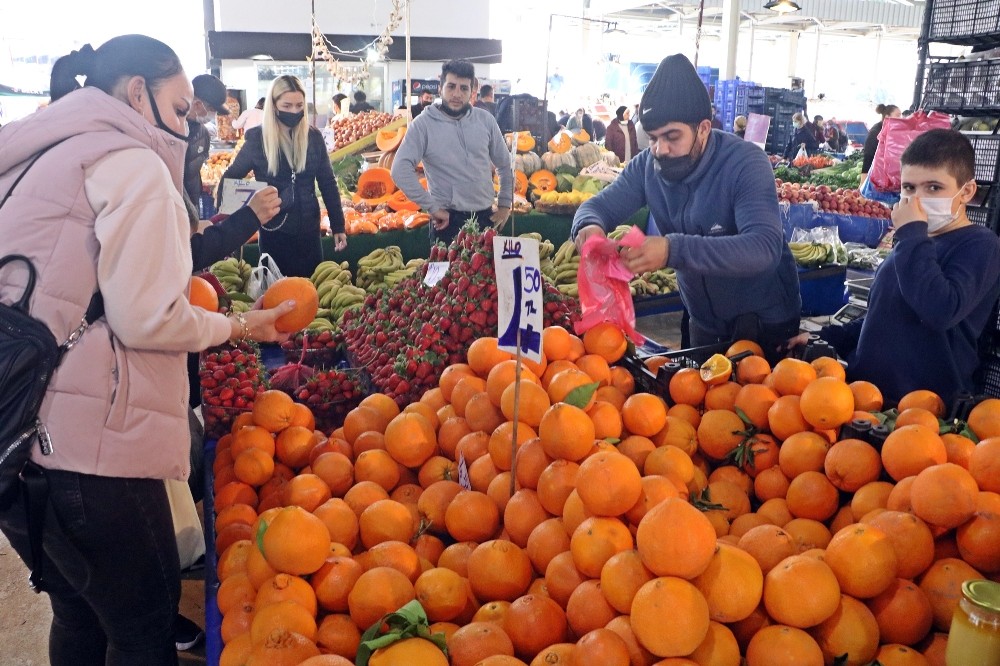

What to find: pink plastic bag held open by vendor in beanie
left=576, top=227, right=646, bottom=345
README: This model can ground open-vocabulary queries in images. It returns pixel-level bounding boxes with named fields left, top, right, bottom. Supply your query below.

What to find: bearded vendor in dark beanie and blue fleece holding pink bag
left=573, top=54, right=801, bottom=359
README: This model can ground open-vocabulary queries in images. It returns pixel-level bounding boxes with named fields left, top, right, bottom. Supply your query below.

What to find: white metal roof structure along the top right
left=587, top=0, right=925, bottom=40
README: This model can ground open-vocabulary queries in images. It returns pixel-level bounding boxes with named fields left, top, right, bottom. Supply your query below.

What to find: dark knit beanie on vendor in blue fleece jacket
left=639, top=53, right=712, bottom=131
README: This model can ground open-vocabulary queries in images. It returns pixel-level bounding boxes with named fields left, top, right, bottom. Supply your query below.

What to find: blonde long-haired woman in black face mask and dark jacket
left=222, top=75, right=347, bottom=277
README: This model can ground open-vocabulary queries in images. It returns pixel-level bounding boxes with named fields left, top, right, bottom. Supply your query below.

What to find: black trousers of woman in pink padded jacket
left=0, top=470, right=181, bottom=666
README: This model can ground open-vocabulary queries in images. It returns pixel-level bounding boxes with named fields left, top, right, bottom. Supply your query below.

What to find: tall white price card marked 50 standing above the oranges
left=493, top=236, right=545, bottom=362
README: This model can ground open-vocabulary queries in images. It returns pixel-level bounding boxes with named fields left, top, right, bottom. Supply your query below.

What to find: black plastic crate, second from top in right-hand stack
left=922, top=58, right=1000, bottom=115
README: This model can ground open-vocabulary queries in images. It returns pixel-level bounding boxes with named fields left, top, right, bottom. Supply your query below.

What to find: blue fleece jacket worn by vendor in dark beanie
left=573, top=130, right=802, bottom=337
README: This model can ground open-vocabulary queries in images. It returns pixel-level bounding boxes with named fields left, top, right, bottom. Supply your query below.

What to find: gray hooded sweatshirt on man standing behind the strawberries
left=392, top=104, right=514, bottom=213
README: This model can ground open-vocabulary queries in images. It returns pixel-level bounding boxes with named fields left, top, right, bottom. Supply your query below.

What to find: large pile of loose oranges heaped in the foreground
left=215, top=324, right=1000, bottom=666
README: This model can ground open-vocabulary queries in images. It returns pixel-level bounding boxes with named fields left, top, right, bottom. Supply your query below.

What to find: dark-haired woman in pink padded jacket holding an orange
left=0, top=35, right=294, bottom=666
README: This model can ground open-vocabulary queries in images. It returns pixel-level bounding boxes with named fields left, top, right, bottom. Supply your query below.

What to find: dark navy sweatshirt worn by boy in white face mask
left=820, top=222, right=1000, bottom=404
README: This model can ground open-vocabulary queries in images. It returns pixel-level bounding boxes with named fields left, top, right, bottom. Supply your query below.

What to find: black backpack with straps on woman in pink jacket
left=0, top=139, right=104, bottom=592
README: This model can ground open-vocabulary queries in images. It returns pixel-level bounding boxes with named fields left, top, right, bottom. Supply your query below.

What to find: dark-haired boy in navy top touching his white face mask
left=795, top=129, right=1000, bottom=405
